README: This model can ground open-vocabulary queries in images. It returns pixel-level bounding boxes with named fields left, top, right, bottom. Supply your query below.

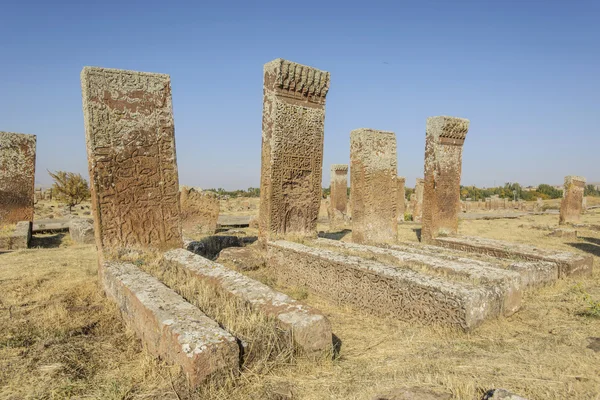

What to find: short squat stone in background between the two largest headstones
left=179, top=186, right=219, bottom=234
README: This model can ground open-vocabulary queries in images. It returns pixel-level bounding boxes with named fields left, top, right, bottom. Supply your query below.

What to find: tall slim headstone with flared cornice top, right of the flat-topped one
left=421, top=116, right=469, bottom=242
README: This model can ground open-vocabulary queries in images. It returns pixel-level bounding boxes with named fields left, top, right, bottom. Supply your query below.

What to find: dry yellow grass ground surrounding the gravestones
left=0, top=201, right=600, bottom=400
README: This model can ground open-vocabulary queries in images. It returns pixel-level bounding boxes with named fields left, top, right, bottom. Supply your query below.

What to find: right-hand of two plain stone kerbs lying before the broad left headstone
left=163, top=249, right=332, bottom=355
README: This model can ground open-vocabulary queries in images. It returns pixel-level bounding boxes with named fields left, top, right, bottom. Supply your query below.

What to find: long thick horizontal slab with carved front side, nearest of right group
left=267, top=241, right=498, bottom=330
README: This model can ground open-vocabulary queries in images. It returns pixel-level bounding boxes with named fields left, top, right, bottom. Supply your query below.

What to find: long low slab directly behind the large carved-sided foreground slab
left=316, top=238, right=523, bottom=315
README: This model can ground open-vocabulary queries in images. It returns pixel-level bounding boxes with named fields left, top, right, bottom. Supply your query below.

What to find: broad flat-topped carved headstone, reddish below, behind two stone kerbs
left=81, top=67, right=182, bottom=250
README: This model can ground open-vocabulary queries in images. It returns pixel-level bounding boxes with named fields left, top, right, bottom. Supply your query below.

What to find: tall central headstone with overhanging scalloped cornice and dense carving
left=259, top=58, right=330, bottom=239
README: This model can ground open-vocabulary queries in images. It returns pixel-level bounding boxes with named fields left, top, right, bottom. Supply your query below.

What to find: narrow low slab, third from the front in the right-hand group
left=386, top=243, right=558, bottom=287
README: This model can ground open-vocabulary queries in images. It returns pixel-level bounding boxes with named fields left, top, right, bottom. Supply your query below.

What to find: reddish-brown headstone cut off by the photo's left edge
left=0, top=132, right=37, bottom=226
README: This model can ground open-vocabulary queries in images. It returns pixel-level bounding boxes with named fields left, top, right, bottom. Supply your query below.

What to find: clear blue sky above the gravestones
left=0, top=0, right=600, bottom=190
